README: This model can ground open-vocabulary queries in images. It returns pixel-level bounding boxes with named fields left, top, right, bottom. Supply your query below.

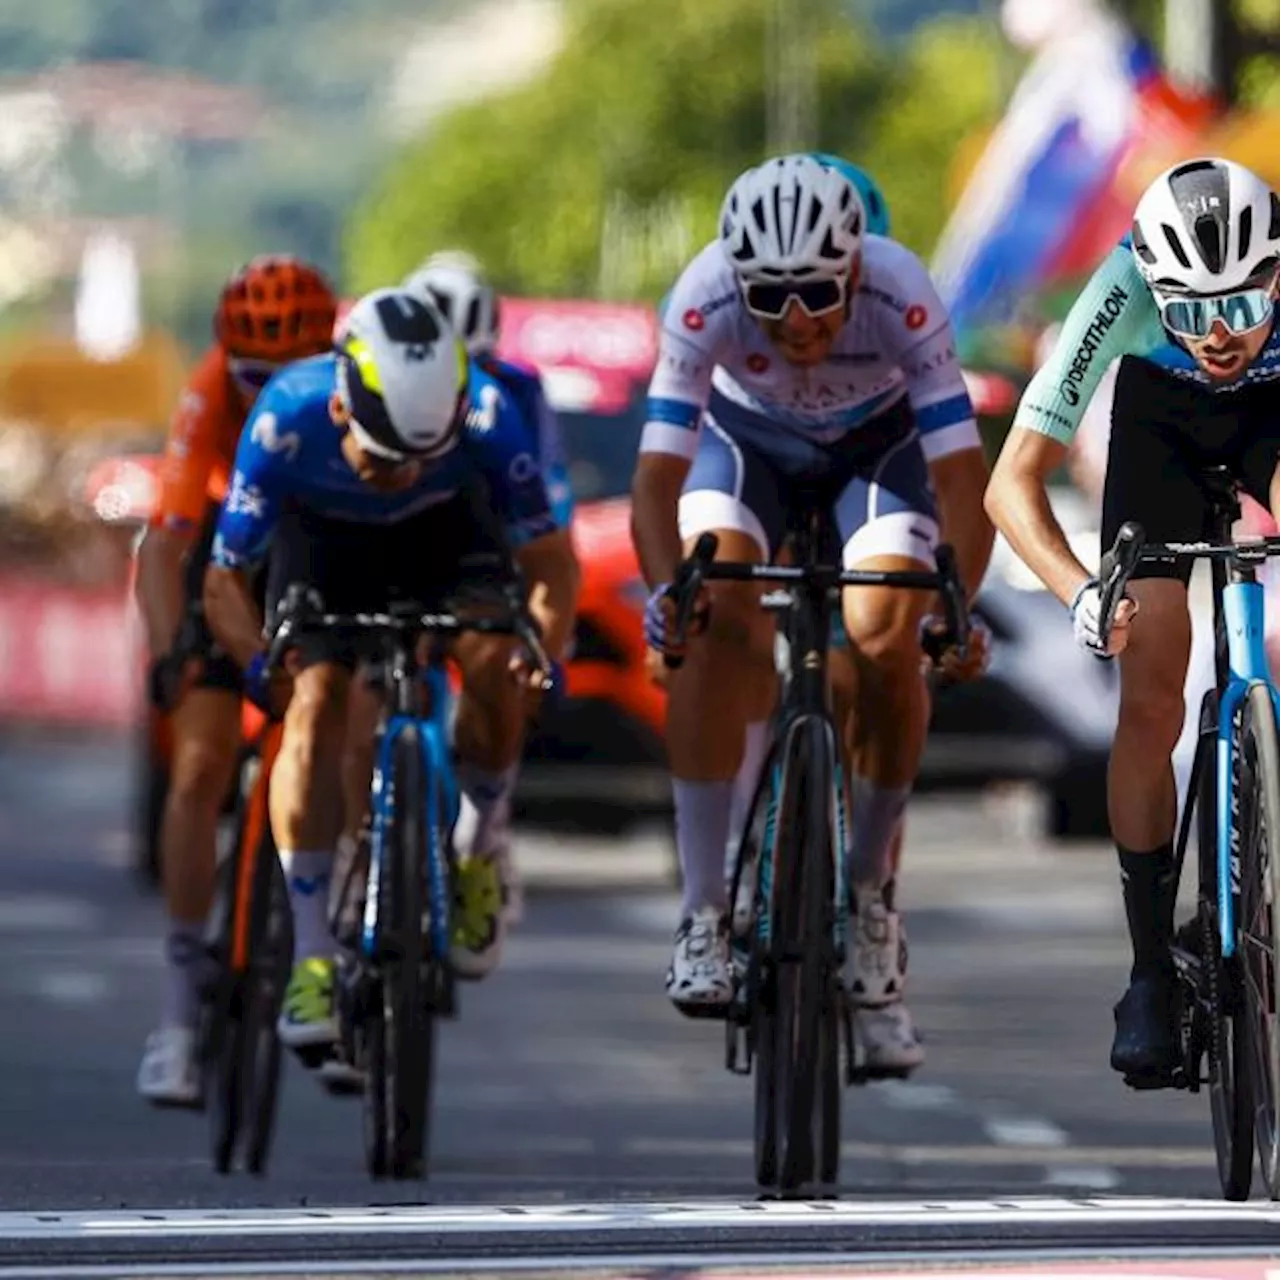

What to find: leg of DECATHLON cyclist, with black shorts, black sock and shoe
left=1102, top=360, right=1213, bottom=1078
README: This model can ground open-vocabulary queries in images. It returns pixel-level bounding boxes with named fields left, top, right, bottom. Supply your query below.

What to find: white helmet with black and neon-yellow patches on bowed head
left=334, top=289, right=467, bottom=461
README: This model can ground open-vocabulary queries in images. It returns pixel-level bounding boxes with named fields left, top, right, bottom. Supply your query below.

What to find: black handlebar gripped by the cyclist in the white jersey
left=663, top=534, right=970, bottom=669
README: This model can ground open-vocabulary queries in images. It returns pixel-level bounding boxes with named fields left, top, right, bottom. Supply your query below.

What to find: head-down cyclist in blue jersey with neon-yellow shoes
left=205, top=289, right=571, bottom=1047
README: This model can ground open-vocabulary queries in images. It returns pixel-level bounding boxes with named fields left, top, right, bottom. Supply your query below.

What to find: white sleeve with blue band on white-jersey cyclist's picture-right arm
left=884, top=243, right=982, bottom=462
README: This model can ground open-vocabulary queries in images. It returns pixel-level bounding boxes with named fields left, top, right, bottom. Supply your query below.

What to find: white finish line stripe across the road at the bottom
left=0, top=1197, right=1280, bottom=1240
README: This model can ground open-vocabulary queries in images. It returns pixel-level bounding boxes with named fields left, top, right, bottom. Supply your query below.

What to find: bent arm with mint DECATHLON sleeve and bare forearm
left=986, top=246, right=1162, bottom=604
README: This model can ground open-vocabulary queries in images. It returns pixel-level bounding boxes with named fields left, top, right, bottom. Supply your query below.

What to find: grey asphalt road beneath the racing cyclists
left=0, top=739, right=1261, bottom=1275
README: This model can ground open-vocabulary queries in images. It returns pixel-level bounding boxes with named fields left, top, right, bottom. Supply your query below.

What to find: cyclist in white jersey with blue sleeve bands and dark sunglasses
left=632, top=155, right=992, bottom=1070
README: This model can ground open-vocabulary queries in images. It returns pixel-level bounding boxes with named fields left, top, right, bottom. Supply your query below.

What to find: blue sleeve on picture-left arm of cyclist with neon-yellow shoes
left=210, top=388, right=291, bottom=568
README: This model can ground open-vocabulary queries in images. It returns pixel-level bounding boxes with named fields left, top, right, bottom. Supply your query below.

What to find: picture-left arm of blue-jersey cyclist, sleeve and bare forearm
left=205, top=422, right=285, bottom=668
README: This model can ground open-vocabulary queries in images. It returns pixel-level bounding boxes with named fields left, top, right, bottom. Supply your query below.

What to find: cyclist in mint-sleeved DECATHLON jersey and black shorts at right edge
left=987, top=159, right=1280, bottom=1087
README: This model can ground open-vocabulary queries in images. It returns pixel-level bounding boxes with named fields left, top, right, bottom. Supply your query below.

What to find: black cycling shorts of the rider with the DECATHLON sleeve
left=1102, top=356, right=1280, bottom=584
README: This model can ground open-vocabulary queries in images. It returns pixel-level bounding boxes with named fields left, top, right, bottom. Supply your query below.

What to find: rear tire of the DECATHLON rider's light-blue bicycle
left=1196, top=700, right=1253, bottom=1201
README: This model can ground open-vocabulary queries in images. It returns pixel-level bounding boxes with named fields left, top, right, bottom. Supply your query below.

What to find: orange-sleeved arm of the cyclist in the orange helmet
left=134, top=388, right=215, bottom=658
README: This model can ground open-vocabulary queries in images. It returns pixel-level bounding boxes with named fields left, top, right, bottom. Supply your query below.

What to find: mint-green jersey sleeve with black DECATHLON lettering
left=1014, top=246, right=1161, bottom=444
